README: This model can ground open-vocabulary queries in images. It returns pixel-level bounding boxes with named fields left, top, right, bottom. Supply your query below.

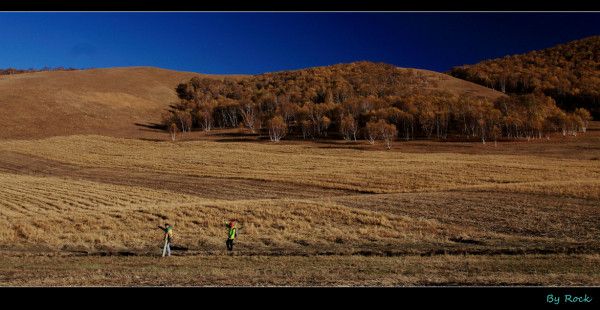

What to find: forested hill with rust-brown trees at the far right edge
left=450, top=36, right=600, bottom=119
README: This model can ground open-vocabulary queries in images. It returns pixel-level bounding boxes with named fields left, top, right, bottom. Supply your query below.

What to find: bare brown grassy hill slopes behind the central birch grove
left=0, top=63, right=502, bottom=139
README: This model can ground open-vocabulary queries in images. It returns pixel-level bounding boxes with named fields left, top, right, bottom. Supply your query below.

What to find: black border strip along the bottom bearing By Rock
left=0, top=287, right=600, bottom=309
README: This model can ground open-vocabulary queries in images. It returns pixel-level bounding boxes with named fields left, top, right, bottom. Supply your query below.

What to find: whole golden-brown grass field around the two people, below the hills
left=0, top=126, right=600, bottom=285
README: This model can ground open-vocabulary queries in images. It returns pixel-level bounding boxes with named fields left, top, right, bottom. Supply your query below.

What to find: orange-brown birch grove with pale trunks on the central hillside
left=162, top=62, right=592, bottom=144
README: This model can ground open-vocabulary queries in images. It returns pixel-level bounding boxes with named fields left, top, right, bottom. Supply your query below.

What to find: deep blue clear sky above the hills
left=0, top=13, right=600, bottom=74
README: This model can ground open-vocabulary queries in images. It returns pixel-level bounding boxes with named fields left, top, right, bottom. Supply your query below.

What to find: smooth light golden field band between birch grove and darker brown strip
left=0, top=136, right=600, bottom=195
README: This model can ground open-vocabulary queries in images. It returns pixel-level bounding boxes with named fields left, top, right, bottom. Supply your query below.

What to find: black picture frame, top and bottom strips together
left=0, top=0, right=600, bottom=309
